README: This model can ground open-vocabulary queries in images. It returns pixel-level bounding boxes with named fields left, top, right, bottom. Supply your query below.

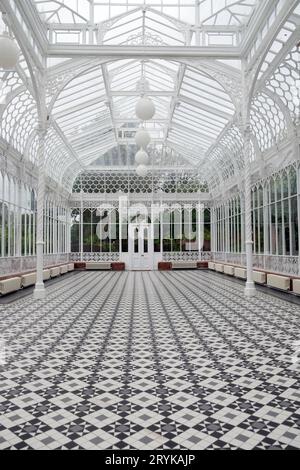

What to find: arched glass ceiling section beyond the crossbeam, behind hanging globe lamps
left=52, top=60, right=235, bottom=174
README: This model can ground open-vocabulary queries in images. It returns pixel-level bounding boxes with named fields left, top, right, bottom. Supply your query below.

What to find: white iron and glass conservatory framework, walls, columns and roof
left=0, top=0, right=300, bottom=298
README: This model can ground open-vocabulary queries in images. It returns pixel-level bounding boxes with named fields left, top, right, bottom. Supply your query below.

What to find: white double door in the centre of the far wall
left=129, top=223, right=154, bottom=271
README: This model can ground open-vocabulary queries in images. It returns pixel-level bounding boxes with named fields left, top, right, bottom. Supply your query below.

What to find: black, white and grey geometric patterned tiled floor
left=0, top=271, right=300, bottom=450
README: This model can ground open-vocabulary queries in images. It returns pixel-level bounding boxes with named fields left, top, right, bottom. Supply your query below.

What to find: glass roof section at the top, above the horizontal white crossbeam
left=35, top=0, right=262, bottom=50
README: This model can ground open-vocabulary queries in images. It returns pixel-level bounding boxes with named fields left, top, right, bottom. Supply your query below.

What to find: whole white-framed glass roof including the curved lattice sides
left=0, top=0, right=300, bottom=194
